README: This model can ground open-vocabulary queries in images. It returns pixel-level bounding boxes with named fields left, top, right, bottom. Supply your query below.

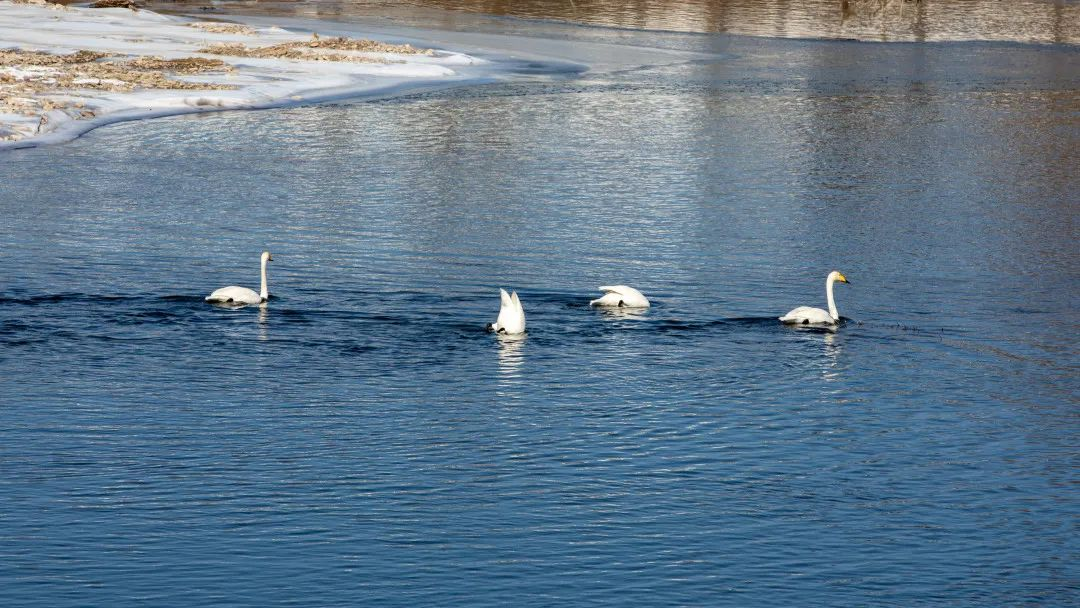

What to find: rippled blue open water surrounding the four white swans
left=0, top=16, right=1080, bottom=607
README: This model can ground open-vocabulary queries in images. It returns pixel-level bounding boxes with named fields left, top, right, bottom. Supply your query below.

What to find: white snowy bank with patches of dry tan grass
left=0, top=0, right=486, bottom=149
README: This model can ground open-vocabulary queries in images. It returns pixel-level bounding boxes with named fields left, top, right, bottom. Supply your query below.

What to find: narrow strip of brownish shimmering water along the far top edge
left=148, top=0, right=1080, bottom=44
